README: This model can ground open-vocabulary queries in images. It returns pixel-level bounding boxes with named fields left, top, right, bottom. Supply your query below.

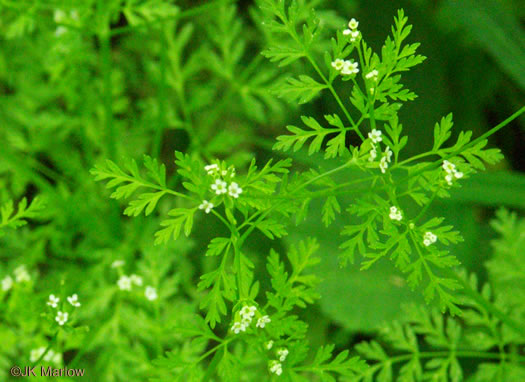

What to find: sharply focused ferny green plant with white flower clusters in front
left=88, top=0, right=524, bottom=381
